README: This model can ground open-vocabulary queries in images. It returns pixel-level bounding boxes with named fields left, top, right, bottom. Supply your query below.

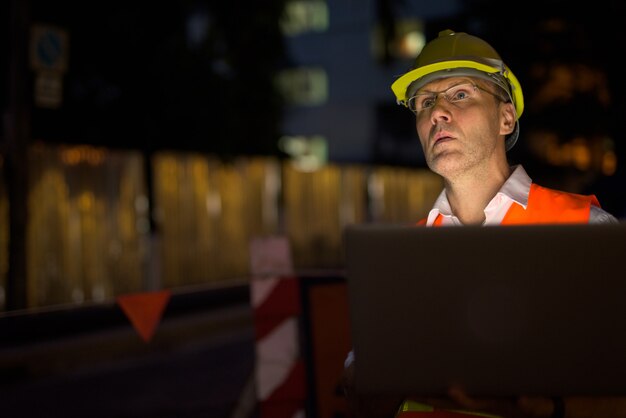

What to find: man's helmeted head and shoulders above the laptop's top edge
left=391, top=30, right=617, bottom=229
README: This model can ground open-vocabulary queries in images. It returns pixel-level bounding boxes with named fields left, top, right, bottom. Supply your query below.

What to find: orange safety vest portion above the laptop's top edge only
left=418, top=183, right=600, bottom=226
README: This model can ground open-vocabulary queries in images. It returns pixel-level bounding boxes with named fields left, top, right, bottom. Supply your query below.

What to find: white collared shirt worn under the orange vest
left=426, top=164, right=618, bottom=226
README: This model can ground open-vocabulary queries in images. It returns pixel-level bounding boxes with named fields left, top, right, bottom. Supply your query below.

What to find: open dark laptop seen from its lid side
left=344, top=223, right=626, bottom=396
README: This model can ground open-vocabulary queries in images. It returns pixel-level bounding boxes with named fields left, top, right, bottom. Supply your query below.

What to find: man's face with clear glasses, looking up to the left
left=416, top=77, right=515, bottom=179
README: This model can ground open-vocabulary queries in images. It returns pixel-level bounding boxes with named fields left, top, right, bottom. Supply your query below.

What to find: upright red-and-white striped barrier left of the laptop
left=250, top=237, right=307, bottom=418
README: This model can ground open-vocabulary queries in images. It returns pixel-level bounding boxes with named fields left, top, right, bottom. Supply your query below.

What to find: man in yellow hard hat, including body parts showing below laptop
left=344, top=30, right=626, bottom=418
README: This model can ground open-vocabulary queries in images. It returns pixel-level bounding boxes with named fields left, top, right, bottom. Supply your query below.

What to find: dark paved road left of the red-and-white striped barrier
left=0, top=298, right=255, bottom=418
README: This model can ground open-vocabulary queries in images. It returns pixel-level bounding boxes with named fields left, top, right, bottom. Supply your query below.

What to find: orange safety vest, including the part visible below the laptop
left=396, top=183, right=600, bottom=418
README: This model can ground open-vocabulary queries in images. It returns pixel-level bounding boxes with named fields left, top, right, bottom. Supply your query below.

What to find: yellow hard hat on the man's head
left=391, top=29, right=524, bottom=151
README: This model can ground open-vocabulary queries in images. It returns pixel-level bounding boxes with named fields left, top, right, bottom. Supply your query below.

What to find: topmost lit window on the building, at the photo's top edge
left=281, top=0, right=328, bottom=36
